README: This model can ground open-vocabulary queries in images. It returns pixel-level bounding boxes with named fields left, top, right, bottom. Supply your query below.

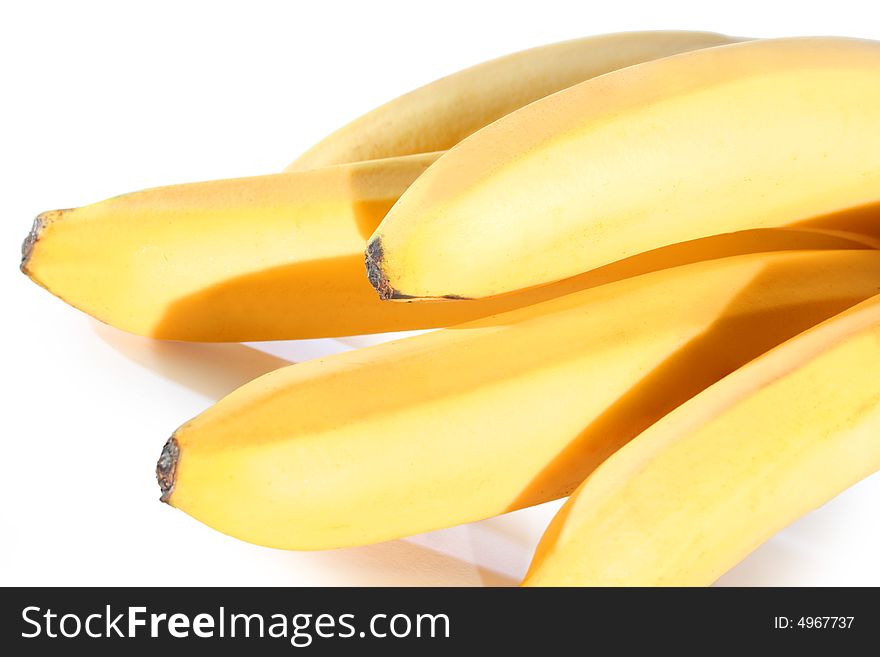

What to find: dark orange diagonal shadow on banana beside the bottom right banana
left=508, top=254, right=880, bottom=516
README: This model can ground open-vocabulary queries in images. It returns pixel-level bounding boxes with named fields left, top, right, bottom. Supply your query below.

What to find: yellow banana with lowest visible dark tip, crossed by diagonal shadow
left=157, top=250, right=880, bottom=549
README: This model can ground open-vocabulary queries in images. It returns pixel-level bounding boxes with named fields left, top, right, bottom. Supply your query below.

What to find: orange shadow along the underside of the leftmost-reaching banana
left=152, top=226, right=868, bottom=342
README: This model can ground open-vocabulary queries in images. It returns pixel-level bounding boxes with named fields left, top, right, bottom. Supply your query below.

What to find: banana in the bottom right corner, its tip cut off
left=523, top=297, right=880, bottom=586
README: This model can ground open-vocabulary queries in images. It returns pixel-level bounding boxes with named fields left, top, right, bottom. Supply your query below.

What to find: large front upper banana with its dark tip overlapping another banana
left=366, top=38, right=880, bottom=298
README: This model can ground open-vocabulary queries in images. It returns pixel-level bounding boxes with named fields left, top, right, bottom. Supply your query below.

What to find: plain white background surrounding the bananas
left=0, top=0, right=880, bottom=585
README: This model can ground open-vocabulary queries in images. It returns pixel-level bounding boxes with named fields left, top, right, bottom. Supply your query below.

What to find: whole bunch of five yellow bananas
left=22, top=32, right=880, bottom=585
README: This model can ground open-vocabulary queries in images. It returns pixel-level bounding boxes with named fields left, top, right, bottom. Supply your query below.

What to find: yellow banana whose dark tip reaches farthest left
left=22, top=155, right=864, bottom=342
